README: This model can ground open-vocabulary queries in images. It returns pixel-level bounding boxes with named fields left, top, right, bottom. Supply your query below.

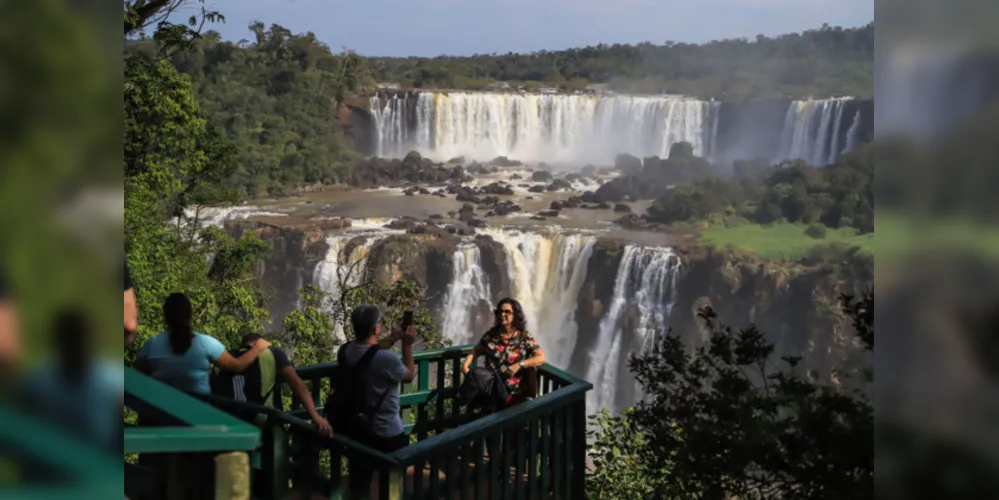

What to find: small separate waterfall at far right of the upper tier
left=775, top=97, right=860, bottom=166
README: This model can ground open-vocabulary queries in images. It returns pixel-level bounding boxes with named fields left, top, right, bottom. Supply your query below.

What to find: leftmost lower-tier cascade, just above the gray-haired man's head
left=312, top=232, right=389, bottom=342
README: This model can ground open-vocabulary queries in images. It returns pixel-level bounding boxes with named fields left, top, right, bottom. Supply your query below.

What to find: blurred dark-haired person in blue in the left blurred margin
left=21, top=310, right=124, bottom=452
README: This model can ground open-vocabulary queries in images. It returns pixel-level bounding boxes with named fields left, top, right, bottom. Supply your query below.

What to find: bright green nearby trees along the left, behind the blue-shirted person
left=124, top=1, right=436, bottom=368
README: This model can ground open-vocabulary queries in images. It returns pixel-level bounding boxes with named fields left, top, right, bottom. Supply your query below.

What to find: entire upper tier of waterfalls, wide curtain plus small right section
left=370, top=92, right=873, bottom=165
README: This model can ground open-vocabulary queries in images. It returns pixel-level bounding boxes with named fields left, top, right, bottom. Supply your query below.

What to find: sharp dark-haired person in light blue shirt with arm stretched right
left=135, top=293, right=271, bottom=395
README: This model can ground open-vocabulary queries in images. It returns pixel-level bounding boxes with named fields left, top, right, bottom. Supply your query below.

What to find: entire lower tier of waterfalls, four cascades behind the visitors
left=314, top=228, right=680, bottom=412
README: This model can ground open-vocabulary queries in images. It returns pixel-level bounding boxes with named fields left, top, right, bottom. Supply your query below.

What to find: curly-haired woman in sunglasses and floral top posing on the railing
left=462, top=298, right=545, bottom=406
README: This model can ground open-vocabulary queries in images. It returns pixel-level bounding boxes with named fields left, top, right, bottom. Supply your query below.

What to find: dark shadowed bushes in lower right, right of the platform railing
left=588, top=291, right=874, bottom=500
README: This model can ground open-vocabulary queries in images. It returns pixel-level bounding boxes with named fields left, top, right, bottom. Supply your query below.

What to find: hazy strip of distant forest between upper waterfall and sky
left=368, top=23, right=874, bottom=99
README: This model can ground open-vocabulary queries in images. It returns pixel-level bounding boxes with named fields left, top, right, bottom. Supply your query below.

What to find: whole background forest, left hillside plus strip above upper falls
left=126, top=22, right=874, bottom=198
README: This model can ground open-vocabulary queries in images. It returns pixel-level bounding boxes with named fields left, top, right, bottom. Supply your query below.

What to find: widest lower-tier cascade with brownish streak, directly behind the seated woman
left=484, top=229, right=596, bottom=367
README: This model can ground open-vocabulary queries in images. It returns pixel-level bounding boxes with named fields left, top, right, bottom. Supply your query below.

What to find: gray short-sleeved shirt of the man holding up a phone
left=344, top=342, right=406, bottom=438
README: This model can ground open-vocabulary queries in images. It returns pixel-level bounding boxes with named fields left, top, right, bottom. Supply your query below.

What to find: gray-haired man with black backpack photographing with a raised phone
left=326, top=304, right=416, bottom=497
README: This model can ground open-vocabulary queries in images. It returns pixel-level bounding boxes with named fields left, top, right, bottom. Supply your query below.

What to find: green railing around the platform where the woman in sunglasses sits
left=262, top=346, right=592, bottom=500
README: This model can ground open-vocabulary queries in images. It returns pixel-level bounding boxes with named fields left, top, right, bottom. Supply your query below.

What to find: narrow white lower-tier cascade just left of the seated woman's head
left=441, top=244, right=493, bottom=345
